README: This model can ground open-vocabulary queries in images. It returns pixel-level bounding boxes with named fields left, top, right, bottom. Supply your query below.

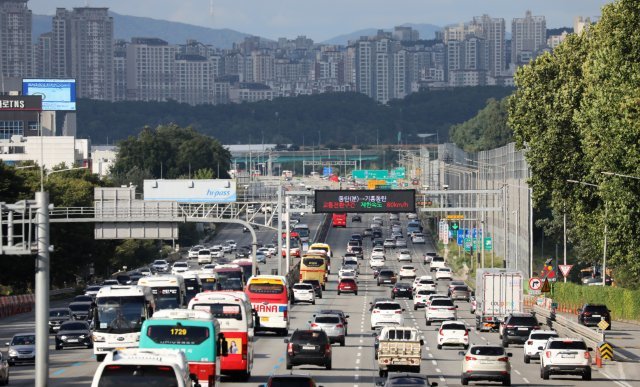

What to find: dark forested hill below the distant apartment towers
left=78, top=87, right=513, bottom=145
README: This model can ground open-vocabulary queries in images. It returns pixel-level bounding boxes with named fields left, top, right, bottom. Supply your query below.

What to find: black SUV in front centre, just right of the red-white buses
left=284, top=330, right=331, bottom=370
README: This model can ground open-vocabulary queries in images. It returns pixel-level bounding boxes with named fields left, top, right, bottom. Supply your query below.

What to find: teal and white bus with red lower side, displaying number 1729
left=140, top=309, right=229, bottom=387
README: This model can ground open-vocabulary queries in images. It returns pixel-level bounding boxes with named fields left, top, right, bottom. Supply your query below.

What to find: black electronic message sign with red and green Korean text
left=315, top=189, right=416, bottom=213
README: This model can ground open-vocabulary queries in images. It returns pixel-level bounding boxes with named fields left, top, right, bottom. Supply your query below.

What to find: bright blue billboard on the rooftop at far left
left=22, top=79, right=76, bottom=111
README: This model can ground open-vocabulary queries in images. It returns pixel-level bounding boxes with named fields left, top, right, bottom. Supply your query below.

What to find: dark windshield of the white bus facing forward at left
left=95, top=296, right=146, bottom=333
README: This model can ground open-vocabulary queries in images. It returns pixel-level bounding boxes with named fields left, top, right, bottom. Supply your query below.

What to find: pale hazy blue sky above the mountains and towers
left=28, top=0, right=611, bottom=42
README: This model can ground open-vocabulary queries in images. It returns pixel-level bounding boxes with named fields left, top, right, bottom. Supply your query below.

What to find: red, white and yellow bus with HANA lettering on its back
left=245, top=275, right=289, bottom=336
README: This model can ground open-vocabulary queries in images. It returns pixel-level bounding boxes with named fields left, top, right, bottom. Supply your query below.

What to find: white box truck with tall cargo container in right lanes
left=475, top=269, right=523, bottom=331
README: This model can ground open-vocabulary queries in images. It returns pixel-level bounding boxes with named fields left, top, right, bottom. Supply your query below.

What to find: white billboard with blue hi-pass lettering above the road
left=144, top=179, right=236, bottom=203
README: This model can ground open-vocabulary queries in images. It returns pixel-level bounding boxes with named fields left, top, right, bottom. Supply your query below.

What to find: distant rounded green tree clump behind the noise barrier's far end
left=449, top=98, right=513, bottom=152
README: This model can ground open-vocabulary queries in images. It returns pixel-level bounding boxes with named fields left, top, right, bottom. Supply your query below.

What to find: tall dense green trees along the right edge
left=509, top=0, right=640, bottom=283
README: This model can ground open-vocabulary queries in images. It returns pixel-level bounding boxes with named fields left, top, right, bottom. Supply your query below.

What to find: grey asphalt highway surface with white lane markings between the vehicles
left=0, top=215, right=640, bottom=387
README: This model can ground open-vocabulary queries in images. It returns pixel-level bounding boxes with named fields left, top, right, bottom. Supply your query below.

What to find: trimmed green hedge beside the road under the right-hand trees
left=553, top=282, right=640, bottom=321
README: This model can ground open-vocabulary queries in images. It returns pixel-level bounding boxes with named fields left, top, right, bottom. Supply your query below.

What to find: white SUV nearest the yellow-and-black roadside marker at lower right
left=538, top=338, right=592, bottom=380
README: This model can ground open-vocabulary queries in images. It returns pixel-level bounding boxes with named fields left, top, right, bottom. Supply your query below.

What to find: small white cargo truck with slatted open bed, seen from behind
left=374, top=326, right=424, bottom=378
